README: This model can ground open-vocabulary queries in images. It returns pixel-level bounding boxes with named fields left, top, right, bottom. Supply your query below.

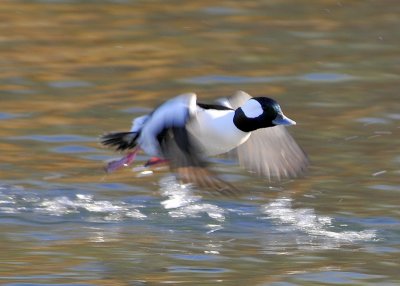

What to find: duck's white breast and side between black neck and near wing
left=187, top=108, right=250, bottom=156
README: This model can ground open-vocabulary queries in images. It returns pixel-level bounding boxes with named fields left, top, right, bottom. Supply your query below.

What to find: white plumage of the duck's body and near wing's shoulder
left=131, top=93, right=250, bottom=156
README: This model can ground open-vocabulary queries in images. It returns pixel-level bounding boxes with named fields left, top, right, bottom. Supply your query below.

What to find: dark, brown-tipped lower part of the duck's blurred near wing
left=160, top=127, right=238, bottom=195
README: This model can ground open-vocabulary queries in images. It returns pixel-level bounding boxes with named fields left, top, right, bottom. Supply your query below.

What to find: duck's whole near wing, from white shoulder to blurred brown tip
left=152, top=93, right=241, bottom=195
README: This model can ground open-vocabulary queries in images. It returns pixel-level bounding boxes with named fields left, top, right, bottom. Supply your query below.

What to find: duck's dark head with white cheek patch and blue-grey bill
left=233, top=97, right=296, bottom=132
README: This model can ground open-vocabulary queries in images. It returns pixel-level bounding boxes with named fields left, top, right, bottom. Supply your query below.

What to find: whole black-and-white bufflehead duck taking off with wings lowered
left=101, top=91, right=308, bottom=192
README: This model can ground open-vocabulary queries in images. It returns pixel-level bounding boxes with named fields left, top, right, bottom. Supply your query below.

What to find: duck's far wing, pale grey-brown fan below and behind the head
left=220, top=91, right=309, bottom=180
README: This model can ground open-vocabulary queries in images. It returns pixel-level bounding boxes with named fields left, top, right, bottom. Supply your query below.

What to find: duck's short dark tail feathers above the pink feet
left=100, top=132, right=139, bottom=151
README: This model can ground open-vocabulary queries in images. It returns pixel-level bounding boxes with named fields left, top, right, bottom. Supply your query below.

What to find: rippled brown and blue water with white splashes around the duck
left=0, top=0, right=400, bottom=286
